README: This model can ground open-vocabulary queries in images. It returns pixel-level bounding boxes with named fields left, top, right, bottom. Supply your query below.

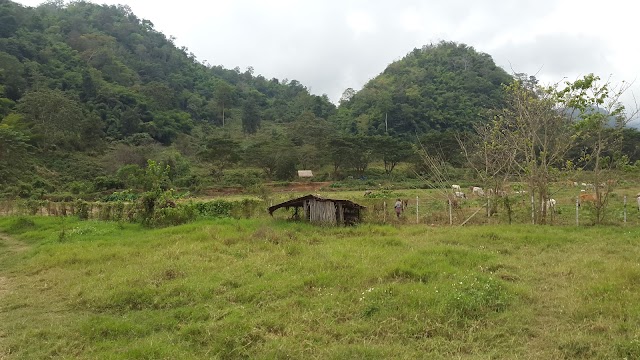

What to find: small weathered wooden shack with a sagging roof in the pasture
left=269, top=195, right=365, bottom=225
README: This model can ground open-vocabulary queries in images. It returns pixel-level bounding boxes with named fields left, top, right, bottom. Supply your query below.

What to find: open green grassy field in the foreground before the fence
left=0, top=217, right=640, bottom=359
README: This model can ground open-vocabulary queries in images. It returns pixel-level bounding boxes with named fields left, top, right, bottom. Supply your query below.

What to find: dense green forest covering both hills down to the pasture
left=0, top=1, right=640, bottom=201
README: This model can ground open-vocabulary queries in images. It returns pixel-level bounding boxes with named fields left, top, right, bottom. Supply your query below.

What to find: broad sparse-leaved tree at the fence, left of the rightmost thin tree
left=460, top=74, right=575, bottom=224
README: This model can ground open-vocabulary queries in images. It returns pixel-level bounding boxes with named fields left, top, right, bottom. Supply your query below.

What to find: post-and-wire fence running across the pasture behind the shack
left=0, top=194, right=640, bottom=226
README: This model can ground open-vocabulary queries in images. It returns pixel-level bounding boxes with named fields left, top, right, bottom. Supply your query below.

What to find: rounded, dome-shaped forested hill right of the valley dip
left=340, top=42, right=511, bottom=136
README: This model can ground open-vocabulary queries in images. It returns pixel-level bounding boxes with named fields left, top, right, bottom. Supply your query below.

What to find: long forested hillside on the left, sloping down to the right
left=0, top=1, right=335, bottom=151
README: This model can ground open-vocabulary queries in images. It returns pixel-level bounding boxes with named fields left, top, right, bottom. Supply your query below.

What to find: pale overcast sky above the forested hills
left=13, top=0, right=640, bottom=121
